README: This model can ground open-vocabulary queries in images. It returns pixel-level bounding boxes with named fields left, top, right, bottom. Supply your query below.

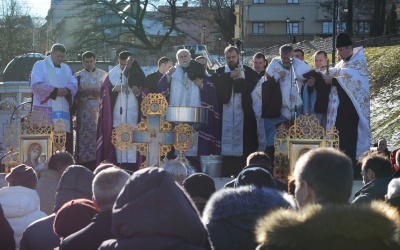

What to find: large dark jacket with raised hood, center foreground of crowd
left=99, top=168, right=211, bottom=250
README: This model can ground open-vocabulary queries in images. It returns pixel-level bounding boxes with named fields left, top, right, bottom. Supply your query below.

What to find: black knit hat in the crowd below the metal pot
left=182, top=173, right=216, bottom=200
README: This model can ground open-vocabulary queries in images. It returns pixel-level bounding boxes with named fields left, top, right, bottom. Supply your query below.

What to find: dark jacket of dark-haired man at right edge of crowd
left=352, top=176, right=392, bottom=204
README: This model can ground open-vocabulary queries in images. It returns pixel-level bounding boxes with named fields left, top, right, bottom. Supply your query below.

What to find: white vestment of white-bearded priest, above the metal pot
left=169, top=66, right=201, bottom=107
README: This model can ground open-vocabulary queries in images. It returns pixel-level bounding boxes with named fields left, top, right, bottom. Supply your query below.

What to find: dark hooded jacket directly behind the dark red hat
left=21, top=165, right=94, bottom=250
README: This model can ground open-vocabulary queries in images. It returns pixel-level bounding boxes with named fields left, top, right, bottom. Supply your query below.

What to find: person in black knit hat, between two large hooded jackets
left=182, top=173, right=216, bottom=214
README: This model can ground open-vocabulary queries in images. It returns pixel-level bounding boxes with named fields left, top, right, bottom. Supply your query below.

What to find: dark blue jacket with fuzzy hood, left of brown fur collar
left=202, top=186, right=295, bottom=250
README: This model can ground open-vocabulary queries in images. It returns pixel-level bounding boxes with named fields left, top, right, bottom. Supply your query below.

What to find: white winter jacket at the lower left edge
left=0, top=186, right=47, bottom=249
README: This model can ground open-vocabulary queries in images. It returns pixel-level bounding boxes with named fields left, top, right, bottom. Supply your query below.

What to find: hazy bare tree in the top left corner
left=0, top=0, right=35, bottom=62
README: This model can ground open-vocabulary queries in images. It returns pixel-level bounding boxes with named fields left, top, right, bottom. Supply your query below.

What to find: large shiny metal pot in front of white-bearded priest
left=165, top=106, right=208, bottom=130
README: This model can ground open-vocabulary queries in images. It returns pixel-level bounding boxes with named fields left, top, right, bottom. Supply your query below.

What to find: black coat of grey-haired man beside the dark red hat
left=60, top=210, right=115, bottom=250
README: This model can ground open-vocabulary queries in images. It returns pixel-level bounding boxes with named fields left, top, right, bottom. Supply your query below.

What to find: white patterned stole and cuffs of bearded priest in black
left=221, top=65, right=245, bottom=156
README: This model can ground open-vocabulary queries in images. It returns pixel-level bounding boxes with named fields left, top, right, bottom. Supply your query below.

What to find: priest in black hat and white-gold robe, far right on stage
left=323, top=33, right=371, bottom=178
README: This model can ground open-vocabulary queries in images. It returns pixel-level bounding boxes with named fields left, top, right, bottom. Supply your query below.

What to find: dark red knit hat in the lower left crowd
left=53, top=199, right=97, bottom=238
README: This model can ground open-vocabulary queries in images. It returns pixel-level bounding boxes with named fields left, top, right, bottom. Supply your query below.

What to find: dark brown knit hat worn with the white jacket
left=6, top=164, right=37, bottom=189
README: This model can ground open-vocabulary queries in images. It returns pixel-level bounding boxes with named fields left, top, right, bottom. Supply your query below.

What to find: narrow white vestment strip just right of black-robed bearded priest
left=251, top=76, right=267, bottom=151
